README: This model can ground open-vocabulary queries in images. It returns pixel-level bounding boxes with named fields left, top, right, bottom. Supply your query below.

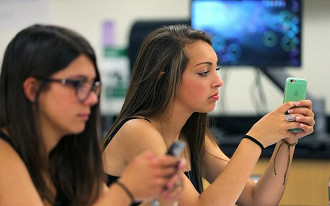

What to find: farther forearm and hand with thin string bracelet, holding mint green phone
left=235, top=100, right=314, bottom=205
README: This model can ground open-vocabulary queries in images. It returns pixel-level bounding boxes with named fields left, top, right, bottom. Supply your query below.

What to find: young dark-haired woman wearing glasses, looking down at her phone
left=0, top=25, right=183, bottom=206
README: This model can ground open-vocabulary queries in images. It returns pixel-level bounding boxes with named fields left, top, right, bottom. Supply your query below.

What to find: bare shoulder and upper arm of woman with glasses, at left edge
left=0, top=139, right=42, bottom=206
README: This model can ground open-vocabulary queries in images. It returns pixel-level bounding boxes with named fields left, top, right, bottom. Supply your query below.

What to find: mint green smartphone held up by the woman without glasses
left=283, top=77, right=307, bottom=133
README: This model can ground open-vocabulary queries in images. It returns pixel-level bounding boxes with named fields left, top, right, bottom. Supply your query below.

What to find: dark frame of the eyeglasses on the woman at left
left=39, top=78, right=102, bottom=102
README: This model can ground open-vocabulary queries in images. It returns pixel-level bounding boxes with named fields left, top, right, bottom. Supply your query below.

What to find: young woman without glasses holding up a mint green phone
left=103, top=25, right=315, bottom=206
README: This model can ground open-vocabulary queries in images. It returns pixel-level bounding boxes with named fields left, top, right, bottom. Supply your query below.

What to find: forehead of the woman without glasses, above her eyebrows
left=185, top=40, right=218, bottom=65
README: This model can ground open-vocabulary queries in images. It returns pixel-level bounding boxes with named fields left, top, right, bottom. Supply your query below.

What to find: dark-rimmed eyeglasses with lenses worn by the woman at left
left=40, top=78, right=101, bottom=102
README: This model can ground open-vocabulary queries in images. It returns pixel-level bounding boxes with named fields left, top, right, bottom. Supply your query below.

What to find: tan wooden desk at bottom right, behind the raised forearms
left=252, top=158, right=330, bottom=206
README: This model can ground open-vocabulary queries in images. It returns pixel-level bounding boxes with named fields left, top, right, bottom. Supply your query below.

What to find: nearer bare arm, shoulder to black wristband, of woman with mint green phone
left=105, top=120, right=261, bottom=206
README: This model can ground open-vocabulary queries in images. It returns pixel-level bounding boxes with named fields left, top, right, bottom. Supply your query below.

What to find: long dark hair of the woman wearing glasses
left=0, top=25, right=103, bottom=205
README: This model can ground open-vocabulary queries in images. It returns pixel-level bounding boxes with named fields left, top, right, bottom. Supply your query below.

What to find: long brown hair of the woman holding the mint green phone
left=105, top=25, right=212, bottom=192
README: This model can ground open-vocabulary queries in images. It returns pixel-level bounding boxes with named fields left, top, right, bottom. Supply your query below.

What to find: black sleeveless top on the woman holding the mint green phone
left=103, top=117, right=201, bottom=206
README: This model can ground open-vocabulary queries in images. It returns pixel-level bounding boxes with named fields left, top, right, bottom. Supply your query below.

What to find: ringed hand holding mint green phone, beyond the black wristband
left=247, top=100, right=315, bottom=147
